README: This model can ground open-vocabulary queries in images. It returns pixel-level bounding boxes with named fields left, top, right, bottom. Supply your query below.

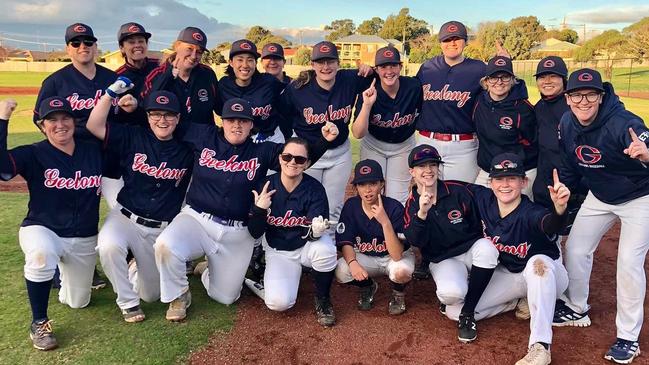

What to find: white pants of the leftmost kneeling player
left=18, top=226, right=97, bottom=308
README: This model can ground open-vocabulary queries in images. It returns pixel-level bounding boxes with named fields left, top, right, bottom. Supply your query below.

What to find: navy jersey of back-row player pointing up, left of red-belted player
left=354, top=76, right=421, bottom=143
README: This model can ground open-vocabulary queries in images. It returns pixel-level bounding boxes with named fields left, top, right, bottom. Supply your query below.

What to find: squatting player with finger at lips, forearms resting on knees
left=336, top=160, right=415, bottom=315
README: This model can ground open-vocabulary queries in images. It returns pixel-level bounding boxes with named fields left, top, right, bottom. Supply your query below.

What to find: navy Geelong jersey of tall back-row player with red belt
left=417, top=55, right=486, bottom=134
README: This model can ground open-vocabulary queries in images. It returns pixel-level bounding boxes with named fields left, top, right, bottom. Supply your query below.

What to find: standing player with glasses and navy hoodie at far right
left=554, top=68, right=649, bottom=364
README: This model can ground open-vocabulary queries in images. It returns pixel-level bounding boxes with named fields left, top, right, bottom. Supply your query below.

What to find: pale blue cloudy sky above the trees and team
left=0, top=0, right=649, bottom=50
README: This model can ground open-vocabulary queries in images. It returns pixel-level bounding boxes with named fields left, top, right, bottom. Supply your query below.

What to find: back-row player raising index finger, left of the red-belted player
left=352, top=46, right=422, bottom=204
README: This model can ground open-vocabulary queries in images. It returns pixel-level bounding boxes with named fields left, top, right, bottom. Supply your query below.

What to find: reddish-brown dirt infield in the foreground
left=189, top=225, right=649, bottom=365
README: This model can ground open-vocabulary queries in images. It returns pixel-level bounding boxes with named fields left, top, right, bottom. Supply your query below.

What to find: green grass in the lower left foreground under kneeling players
left=0, top=193, right=235, bottom=364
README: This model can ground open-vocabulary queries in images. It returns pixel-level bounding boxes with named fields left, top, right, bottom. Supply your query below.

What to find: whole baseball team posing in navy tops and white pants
left=0, top=21, right=649, bottom=365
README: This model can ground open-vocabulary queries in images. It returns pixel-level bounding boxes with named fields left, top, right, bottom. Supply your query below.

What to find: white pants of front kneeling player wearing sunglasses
left=263, top=235, right=336, bottom=312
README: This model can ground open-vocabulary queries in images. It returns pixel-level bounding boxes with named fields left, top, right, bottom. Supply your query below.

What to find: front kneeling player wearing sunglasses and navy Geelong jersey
left=240, top=137, right=336, bottom=327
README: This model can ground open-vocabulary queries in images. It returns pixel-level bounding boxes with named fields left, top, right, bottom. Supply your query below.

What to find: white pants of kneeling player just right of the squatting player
left=429, top=238, right=499, bottom=306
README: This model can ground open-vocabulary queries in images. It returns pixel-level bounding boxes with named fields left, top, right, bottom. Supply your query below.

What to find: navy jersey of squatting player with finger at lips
left=336, top=196, right=410, bottom=256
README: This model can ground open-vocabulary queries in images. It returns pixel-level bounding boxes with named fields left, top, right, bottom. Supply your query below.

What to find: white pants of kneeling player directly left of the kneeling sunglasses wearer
left=153, top=205, right=255, bottom=305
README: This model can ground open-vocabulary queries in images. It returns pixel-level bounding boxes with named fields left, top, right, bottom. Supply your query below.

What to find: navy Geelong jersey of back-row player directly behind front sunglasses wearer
left=282, top=70, right=372, bottom=148
